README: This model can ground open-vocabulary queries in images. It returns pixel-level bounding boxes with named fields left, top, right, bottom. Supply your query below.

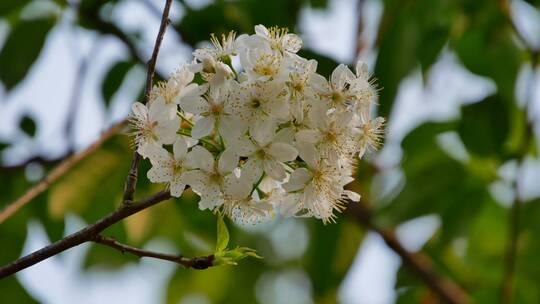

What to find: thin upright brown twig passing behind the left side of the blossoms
left=124, top=0, right=172, bottom=203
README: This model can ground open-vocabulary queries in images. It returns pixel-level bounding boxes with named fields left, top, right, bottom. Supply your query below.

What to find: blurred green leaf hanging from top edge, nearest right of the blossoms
left=374, top=0, right=456, bottom=117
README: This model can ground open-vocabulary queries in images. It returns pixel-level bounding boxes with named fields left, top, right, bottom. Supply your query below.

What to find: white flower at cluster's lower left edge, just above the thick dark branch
left=147, top=137, right=189, bottom=197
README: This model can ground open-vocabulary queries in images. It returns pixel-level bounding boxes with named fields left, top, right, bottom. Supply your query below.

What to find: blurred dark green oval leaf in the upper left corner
left=0, top=18, right=54, bottom=91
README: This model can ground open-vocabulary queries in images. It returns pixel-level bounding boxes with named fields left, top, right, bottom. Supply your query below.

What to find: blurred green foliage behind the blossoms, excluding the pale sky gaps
left=0, top=0, right=540, bottom=303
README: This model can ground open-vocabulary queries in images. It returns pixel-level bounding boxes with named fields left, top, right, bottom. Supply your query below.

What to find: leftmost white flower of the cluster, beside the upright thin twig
left=129, top=99, right=180, bottom=157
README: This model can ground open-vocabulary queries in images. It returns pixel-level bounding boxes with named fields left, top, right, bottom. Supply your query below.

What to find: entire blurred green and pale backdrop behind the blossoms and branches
left=0, top=0, right=540, bottom=304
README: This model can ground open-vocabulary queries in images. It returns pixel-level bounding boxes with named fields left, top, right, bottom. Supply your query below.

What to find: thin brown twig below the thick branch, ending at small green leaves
left=92, top=235, right=214, bottom=269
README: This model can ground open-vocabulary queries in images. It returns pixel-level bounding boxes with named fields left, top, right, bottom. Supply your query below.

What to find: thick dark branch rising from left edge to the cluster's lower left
left=0, top=190, right=171, bottom=279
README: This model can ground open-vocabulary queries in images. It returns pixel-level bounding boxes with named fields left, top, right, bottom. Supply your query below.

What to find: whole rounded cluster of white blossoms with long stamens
left=130, top=25, right=384, bottom=223
